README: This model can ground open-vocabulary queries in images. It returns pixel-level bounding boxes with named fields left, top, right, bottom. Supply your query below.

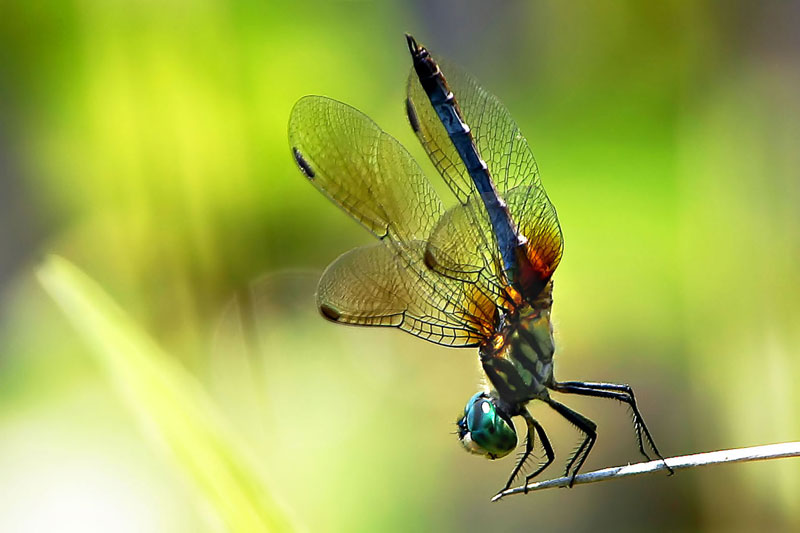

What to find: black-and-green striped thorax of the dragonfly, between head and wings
left=480, top=284, right=555, bottom=406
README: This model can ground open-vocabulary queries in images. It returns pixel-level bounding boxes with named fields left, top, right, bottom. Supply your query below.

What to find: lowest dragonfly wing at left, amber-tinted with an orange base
left=317, top=243, right=494, bottom=346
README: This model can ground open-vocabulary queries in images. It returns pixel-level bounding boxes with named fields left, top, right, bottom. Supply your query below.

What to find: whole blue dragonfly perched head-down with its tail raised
left=289, top=34, right=664, bottom=492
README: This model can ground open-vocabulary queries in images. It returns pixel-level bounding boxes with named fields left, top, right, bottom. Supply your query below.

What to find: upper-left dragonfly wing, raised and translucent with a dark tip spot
left=289, top=96, right=444, bottom=241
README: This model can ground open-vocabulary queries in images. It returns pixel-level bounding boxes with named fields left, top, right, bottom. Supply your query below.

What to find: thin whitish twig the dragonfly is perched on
left=492, top=442, right=800, bottom=502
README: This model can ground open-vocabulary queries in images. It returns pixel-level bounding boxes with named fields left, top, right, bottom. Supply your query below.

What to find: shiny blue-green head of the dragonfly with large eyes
left=458, top=392, right=517, bottom=459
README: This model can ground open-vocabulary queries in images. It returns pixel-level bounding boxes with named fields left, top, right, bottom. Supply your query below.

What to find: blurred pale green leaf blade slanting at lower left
left=38, top=257, right=291, bottom=532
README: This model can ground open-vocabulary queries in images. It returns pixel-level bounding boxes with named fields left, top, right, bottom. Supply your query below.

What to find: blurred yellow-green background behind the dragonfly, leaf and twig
left=0, top=0, right=800, bottom=532
